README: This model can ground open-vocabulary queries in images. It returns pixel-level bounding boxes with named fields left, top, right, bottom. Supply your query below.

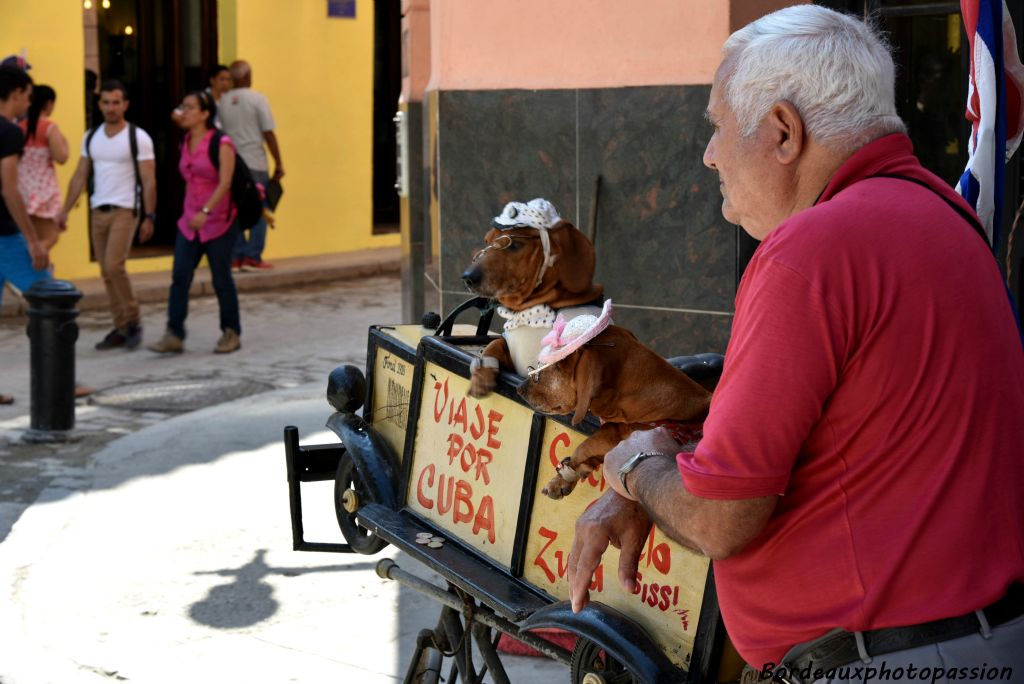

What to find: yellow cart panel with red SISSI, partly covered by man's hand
left=523, top=420, right=710, bottom=669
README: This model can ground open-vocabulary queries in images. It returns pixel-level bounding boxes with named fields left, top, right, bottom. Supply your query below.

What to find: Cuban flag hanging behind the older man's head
left=956, top=0, right=1024, bottom=251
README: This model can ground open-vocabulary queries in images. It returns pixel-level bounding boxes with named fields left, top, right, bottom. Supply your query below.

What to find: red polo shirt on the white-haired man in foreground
left=678, top=135, right=1024, bottom=667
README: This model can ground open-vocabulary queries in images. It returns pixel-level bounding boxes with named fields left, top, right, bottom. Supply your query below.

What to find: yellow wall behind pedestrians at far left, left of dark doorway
left=0, top=0, right=94, bottom=281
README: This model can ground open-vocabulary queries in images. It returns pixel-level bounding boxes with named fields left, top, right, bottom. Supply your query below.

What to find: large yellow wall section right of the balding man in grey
left=217, top=0, right=399, bottom=255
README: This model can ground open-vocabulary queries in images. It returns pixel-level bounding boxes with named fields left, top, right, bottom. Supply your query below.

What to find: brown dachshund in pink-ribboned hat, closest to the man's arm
left=518, top=326, right=711, bottom=499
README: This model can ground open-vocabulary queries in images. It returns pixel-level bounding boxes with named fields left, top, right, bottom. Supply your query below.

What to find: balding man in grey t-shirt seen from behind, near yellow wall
left=217, top=59, right=285, bottom=270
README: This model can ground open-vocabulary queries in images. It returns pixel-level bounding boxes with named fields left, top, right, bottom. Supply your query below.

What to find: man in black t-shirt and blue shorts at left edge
left=0, top=66, right=50, bottom=404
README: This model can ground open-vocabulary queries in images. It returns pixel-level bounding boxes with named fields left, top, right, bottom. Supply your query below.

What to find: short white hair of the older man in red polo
left=720, top=5, right=906, bottom=151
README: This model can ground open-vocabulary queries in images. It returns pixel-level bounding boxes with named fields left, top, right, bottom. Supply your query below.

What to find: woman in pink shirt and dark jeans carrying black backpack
left=150, top=90, right=242, bottom=354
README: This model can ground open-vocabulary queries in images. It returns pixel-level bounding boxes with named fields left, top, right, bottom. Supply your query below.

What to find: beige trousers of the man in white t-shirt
left=91, top=209, right=140, bottom=332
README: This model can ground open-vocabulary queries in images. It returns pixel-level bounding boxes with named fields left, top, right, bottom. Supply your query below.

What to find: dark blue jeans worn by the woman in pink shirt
left=167, top=224, right=242, bottom=340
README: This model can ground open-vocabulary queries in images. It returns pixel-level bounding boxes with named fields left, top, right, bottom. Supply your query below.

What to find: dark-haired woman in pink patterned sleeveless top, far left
left=17, top=85, right=69, bottom=250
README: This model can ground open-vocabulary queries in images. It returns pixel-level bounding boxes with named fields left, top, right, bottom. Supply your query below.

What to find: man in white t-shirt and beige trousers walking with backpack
left=57, top=81, right=157, bottom=349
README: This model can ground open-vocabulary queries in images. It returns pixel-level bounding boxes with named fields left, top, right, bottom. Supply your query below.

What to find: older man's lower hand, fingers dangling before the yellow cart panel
left=567, top=491, right=650, bottom=612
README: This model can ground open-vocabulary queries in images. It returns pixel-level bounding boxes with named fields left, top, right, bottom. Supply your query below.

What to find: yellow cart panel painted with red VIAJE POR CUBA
left=407, top=362, right=534, bottom=568
